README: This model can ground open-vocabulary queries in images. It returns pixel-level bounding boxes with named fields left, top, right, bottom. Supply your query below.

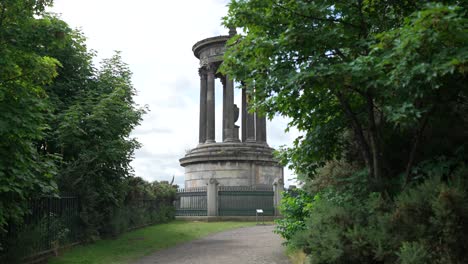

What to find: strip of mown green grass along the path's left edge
left=49, top=221, right=255, bottom=264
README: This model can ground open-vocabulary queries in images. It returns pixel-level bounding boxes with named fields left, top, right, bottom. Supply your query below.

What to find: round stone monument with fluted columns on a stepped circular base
left=180, top=30, right=284, bottom=188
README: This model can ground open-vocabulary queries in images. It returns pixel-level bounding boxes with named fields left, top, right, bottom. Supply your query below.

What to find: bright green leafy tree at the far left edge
left=0, top=0, right=61, bottom=235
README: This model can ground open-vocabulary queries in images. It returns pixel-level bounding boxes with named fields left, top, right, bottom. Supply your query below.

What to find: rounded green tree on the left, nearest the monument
left=58, top=53, right=145, bottom=237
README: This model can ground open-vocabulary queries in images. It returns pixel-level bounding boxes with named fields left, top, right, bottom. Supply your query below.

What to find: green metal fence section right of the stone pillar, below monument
left=218, top=186, right=275, bottom=216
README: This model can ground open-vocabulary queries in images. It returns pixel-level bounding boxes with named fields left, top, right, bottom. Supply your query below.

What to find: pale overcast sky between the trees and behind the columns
left=49, top=0, right=297, bottom=189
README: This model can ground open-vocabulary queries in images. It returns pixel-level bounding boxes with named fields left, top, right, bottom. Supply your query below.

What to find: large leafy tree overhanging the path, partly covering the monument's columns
left=222, top=0, right=468, bottom=191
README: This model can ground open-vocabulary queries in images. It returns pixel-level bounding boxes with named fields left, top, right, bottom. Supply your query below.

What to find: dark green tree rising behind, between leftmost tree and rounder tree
left=34, top=14, right=96, bottom=158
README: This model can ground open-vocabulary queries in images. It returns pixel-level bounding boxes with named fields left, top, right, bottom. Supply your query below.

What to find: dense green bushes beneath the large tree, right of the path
left=288, top=169, right=468, bottom=264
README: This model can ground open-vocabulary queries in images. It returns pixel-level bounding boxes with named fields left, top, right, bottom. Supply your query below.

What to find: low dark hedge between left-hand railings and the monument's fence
left=71, top=177, right=176, bottom=241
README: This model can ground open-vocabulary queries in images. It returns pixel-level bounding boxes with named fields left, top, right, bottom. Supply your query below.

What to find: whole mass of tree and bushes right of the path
left=222, top=0, right=468, bottom=263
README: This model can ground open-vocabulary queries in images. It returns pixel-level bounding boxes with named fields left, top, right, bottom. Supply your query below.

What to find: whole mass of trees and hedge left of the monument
left=0, top=0, right=175, bottom=254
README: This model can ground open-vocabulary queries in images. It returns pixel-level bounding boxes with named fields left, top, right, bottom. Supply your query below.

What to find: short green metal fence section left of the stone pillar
left=175, top=187, right=207, bottom=216
